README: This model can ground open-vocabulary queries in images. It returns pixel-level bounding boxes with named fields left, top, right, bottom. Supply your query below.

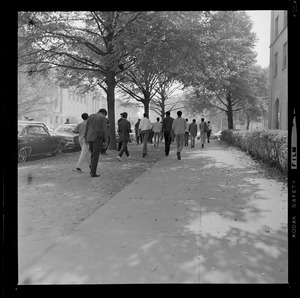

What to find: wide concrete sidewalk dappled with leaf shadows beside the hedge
left=19, top=141, right=288, bottom=284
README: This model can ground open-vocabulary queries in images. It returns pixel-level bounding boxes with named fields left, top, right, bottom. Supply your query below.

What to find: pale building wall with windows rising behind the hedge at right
left=268, top=10, right=288, bottom=130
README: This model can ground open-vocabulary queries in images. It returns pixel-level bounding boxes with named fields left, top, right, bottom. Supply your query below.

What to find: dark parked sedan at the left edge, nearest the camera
left=18, top=121, right=66, bottom=163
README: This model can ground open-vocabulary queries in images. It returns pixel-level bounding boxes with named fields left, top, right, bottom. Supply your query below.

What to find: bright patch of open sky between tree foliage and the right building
left=246, top=10, right=271, bottom=67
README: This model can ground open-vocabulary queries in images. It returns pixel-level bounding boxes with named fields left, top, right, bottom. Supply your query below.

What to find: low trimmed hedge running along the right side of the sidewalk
left=221, top=129, right=288, bottom=172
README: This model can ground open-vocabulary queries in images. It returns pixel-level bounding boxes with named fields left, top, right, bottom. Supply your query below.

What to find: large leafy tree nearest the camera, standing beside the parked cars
left=19, top=11, right=142, bottom=149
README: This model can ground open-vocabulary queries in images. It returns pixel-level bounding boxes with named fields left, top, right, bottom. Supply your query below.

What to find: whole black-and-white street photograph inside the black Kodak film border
left=5, top=9, right=297, bottom=294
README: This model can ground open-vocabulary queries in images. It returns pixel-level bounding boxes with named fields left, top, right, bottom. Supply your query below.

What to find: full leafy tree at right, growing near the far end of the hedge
left=183, top=11, right=256, bottom=129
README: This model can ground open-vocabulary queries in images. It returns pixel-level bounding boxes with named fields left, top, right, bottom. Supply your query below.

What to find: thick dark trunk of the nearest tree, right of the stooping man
left=106, top=71, right=117, bottom=150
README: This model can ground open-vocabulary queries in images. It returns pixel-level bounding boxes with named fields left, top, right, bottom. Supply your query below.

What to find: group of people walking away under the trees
left=73, top=109, right=211, bottom=177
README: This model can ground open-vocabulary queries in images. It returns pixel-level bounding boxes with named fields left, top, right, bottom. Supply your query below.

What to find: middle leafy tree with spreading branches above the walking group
left=118, top=11, right=214, bottom=114
